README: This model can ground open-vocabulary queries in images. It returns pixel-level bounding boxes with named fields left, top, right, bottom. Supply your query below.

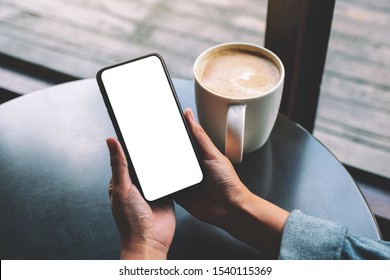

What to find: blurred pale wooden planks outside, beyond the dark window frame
left=0, top=0, right=390, bottom=177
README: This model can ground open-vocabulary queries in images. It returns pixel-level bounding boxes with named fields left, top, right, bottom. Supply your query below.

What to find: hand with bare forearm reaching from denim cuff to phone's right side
left=176, top=109, right=289, bottom=257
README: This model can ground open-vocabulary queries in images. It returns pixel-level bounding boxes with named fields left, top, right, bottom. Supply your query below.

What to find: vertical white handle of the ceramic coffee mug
left=225, top=104, right=246, bottom=163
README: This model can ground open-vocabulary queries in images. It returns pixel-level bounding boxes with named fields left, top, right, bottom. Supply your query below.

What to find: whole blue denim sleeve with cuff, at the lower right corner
left=279, top=210, right=390, bottom=260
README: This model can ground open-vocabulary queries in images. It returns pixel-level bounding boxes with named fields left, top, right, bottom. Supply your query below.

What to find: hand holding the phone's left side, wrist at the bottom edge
left=107, top=138, right=175, bottom=259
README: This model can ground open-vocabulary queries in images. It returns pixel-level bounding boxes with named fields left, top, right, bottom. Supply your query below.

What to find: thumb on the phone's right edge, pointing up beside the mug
left=184, top=108, right=222, bottom=159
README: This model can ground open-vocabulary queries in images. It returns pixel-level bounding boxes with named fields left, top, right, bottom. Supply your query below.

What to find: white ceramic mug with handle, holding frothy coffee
left=193, top=42, right=285, bottom=163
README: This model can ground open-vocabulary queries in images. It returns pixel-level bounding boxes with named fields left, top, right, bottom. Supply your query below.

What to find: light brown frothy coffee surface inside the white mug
left=200, top=49, right=280, bottom=98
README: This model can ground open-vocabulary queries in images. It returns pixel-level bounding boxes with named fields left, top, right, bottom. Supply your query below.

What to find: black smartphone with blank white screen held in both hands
left=97, top=54, right=203, bottom=201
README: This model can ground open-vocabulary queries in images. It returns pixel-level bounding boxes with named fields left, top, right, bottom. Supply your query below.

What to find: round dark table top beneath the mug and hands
left=0, top=79, right=380, bottom=259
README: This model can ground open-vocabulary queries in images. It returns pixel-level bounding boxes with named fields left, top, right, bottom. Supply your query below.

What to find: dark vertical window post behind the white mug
left=265, top=0, right=336, bottom=133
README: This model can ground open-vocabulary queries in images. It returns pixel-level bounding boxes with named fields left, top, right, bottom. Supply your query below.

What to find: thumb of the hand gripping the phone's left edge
left=106, top=138, right=132, bottom=187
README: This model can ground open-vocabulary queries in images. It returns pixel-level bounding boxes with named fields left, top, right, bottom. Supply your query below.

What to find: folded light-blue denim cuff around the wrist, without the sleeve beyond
left=279, top=210, right=348, bottom=260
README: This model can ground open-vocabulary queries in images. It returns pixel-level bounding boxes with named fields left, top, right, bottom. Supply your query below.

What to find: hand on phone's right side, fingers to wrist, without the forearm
left=176, top=109, right=250, bottom=227
